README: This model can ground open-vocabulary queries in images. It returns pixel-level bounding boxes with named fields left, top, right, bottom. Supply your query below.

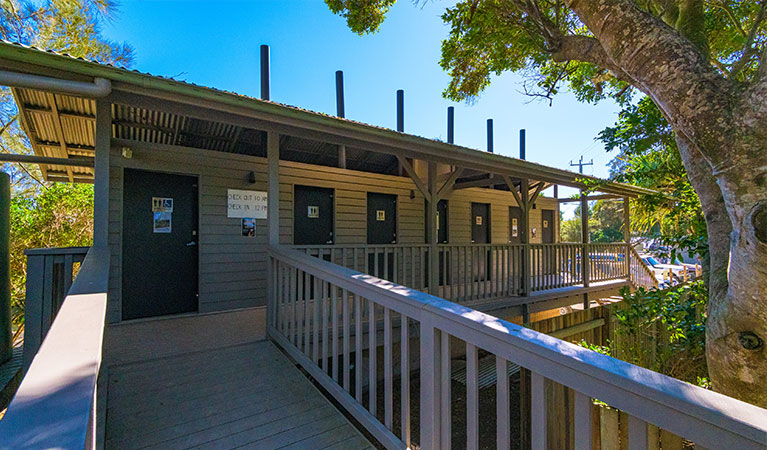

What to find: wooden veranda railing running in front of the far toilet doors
left=294, top=243, right=628, bottom=303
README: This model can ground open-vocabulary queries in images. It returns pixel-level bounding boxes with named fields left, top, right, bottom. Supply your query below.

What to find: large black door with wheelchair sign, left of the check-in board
left=122, top=169, right=198, bottom=320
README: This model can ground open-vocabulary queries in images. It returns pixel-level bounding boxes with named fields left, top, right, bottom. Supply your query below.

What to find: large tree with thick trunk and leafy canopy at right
left=326, top=0, right=767, bottom=407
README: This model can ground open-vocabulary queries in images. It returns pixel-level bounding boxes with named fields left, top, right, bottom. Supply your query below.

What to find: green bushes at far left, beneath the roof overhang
left=10, top=183, right=93, bottom=338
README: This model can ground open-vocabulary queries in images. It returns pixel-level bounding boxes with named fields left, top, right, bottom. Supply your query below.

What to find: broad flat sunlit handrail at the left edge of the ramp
left=0, top=247, right=109, bottom=448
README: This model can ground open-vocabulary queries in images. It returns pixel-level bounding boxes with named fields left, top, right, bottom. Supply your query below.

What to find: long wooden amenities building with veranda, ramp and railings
left=0, top=43, right=767, bottom=449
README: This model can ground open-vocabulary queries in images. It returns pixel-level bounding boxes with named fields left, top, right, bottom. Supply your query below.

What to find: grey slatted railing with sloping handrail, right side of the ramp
left=268, top=247, right=767, bottom=449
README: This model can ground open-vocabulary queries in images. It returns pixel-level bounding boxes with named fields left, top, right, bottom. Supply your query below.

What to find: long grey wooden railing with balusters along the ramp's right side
left=268, top=247, right=767, bottom=449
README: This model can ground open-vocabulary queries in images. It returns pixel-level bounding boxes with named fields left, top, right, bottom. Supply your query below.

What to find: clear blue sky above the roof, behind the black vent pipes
left=103, top=0, right=619, bottom=211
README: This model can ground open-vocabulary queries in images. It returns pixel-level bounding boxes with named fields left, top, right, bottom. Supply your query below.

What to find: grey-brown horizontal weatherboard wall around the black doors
left=108, top=142, right=558, bottom=322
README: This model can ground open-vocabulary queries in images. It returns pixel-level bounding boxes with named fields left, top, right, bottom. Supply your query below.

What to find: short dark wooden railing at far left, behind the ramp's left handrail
left=23, top=247, right=90, bottom=370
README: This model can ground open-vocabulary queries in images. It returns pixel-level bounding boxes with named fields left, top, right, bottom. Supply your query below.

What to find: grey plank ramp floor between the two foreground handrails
left=105, top=341, right=372, bottom=449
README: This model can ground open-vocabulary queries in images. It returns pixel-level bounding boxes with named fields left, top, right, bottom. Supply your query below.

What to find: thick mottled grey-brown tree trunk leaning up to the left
left=569, top=0, right=767, bottom=407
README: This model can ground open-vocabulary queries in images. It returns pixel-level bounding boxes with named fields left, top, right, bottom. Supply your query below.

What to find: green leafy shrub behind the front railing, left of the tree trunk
left=610, top=280, right=708, bottom=385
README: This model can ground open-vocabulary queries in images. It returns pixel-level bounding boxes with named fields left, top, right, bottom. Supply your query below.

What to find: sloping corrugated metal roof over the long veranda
left=0, top=41, right=653, bottom=196
